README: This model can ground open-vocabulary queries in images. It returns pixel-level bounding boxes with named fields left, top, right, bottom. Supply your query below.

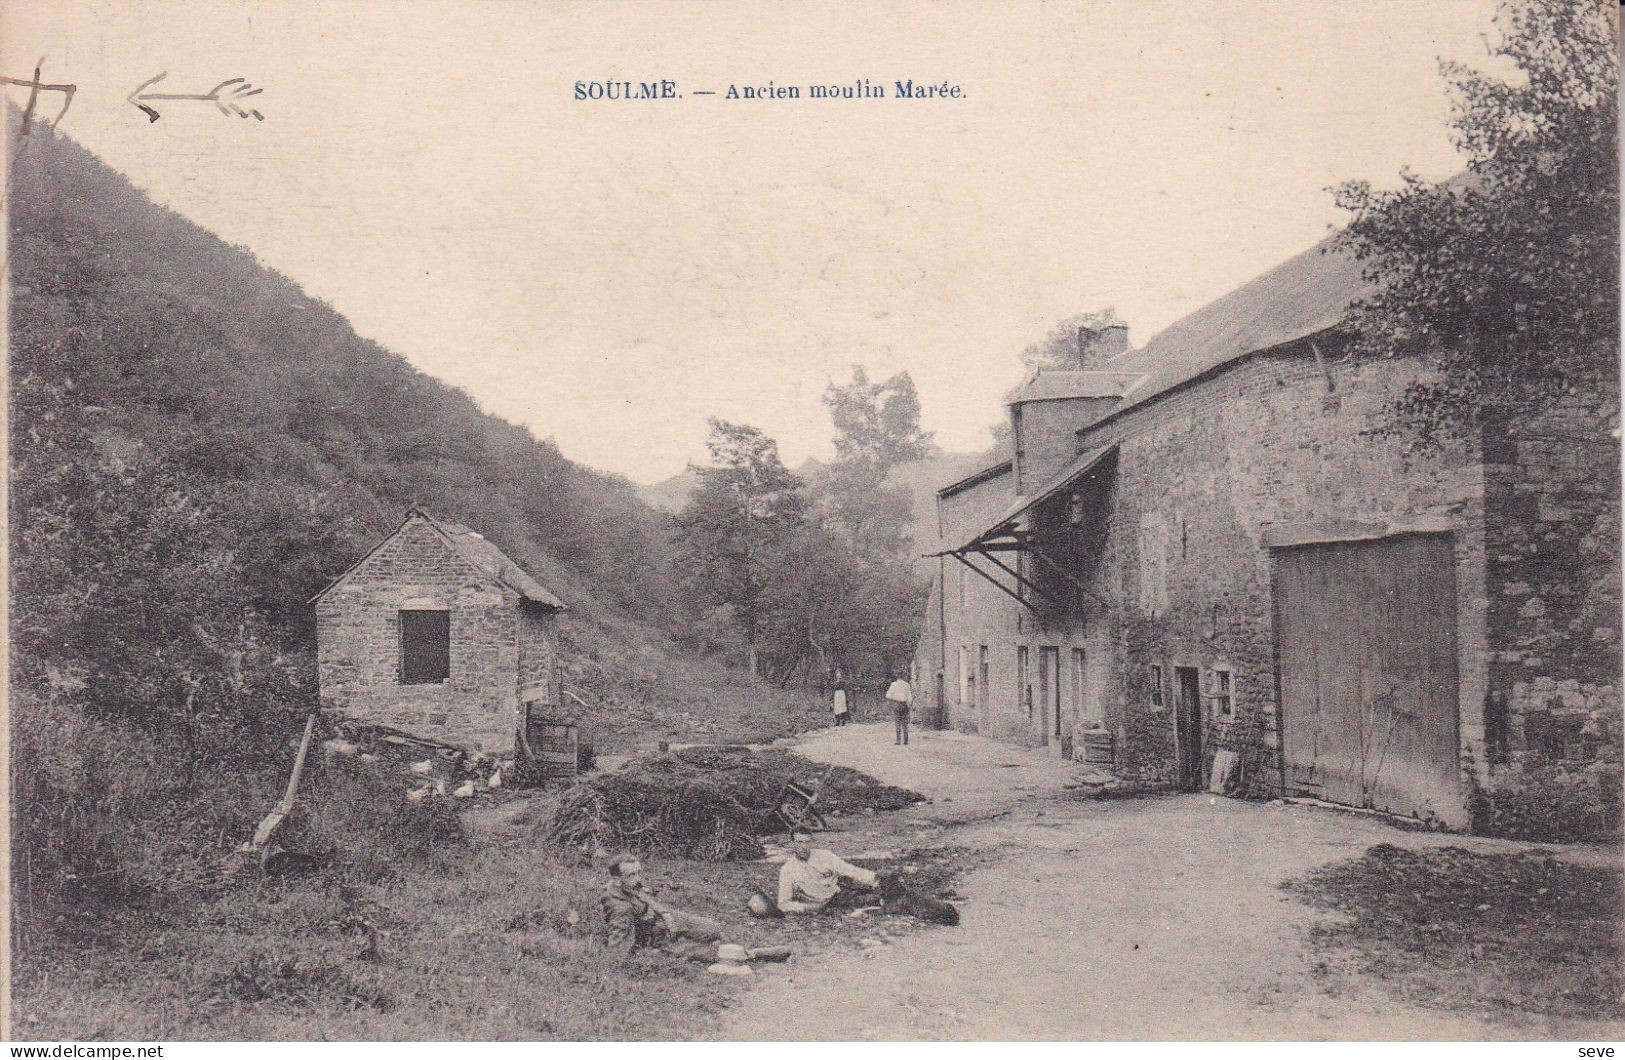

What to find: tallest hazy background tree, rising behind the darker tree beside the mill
left=819, top=366, right=933, bottom=556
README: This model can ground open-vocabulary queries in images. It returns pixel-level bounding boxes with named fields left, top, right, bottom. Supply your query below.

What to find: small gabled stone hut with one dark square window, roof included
left=312, top=509, right=564, bottom=754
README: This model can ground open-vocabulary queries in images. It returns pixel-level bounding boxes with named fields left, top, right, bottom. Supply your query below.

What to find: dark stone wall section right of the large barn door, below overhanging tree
left=1472, top=393, right=1625, bottom=834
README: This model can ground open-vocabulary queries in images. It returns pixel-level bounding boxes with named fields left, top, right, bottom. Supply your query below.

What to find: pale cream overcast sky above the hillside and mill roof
left=0, top=0, right=1493, bottom=481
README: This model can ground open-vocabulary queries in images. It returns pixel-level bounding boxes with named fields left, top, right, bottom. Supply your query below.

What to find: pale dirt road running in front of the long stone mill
left=720, top=725, right=1622, bottom=1040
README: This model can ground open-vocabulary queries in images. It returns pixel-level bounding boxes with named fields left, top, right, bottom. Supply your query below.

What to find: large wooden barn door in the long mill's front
left=1274, top=535, right=1461, bottom=816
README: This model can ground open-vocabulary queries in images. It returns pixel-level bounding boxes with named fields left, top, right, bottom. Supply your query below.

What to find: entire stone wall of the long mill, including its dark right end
left=928, top=341, right=1622, bottom=834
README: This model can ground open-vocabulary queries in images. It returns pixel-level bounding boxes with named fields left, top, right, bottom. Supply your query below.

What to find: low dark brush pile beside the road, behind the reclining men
left=546, top=746, right=921, bottom=862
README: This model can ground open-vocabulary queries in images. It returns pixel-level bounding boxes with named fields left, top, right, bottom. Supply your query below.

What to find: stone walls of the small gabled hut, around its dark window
left=317, top=519, right=551, bottom=754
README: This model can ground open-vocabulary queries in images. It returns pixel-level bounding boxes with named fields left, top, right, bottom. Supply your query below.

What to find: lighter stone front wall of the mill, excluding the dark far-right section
left=944, top=345, right=1487, bottom=819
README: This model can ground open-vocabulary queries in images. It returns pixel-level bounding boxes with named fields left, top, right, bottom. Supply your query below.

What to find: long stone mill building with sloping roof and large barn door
left=915, top=235, right=1622, bottom=831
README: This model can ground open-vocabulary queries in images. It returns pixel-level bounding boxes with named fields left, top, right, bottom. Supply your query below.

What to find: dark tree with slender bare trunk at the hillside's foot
left=678, top=419, right=806, bottom=675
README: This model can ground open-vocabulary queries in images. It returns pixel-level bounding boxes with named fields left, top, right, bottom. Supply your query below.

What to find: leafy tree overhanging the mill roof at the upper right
left=1334, top=0, right=1619, bottom=441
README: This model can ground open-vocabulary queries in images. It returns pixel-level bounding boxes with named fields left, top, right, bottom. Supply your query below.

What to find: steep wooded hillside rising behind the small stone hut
left=8, top=111, right=851, bottom=938
